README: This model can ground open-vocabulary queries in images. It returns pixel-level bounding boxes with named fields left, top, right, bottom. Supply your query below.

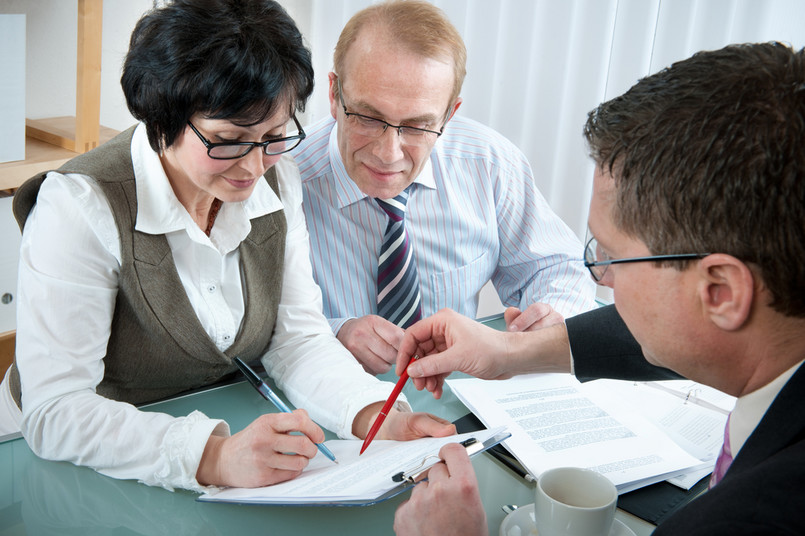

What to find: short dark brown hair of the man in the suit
left=584, top=43, right=805, bottom=317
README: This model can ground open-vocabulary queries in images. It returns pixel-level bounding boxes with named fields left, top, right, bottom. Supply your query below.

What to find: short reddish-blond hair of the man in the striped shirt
left=333, top=0, right=467, bottom=109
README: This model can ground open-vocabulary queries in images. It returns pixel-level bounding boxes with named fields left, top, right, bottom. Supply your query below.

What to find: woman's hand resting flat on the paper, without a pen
left=352, top=402, right=456, bottom=441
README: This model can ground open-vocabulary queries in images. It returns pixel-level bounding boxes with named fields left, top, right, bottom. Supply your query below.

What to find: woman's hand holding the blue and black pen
left=196, top=409, right=324, bottom=488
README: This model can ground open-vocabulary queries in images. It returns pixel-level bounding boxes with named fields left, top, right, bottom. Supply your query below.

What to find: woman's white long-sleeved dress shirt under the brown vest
left=2, top=125, right=407, bottom=490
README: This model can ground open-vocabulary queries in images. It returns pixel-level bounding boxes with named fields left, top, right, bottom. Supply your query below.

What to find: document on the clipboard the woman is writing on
left=198, top=427, right=509, bottom=506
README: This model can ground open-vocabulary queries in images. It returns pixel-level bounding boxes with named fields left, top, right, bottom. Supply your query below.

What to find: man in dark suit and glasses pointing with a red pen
left=395, top=43, right=805, bottom=536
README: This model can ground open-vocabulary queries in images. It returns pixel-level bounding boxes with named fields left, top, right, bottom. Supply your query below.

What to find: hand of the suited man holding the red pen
left=396, top=309, right=514, bottom=398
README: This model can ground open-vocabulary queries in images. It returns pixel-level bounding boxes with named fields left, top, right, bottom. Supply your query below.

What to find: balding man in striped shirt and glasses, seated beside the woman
left=294, top=1, right=595, bottom=374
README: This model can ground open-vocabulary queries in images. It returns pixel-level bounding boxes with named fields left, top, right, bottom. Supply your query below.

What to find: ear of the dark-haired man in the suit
left=698, top=253, right=755, bottom=331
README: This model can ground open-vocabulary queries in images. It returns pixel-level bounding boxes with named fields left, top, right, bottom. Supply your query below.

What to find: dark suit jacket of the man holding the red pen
left=567, top=306, right=805, bottom=536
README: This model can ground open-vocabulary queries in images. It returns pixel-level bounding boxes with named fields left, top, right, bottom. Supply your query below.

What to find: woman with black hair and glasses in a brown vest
left=0, top=0, right=453, bottom=491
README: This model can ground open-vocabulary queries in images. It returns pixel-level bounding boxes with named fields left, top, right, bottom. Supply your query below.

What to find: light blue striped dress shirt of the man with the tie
left=293, top=113, right=595, bottom=334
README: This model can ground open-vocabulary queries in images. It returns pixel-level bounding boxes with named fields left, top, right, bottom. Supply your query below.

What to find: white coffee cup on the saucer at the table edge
left=534, top=467, right=618, bottom=536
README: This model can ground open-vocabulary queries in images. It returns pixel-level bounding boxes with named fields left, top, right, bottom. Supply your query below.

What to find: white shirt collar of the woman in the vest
left=131, top=124, right=283, bottom=252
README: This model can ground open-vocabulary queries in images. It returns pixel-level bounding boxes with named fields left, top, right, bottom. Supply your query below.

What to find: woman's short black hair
left=120, top=0, right=313, bottom=151
